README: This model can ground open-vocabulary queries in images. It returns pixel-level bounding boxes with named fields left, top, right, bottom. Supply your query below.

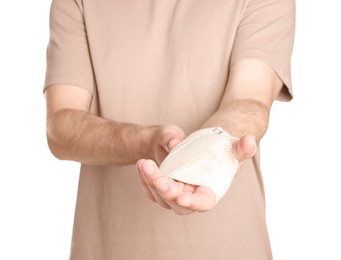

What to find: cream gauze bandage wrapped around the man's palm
left=160, top=127, right=238, bottom=202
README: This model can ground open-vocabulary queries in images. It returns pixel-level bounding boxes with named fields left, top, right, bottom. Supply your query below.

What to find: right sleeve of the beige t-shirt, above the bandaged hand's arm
left=230, top=0, right=295, bottom=101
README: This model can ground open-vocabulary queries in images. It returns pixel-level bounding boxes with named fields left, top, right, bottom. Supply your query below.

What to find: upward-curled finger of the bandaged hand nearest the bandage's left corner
left=141, top=160, right=170, bottom=209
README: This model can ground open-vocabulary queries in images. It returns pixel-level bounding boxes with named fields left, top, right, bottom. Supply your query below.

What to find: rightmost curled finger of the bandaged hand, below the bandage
left=177, top=186, right=216, bottom=212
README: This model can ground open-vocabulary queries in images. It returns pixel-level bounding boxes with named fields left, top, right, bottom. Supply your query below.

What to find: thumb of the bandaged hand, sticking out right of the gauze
left=232, top=135, right=257, bottom=162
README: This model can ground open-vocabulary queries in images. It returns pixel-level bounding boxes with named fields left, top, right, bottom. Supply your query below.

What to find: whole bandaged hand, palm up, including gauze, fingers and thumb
left=137, top=128, right=256, bottom=214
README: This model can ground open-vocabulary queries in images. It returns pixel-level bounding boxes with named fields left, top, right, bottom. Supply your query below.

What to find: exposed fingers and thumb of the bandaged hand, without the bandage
left=136, top=135, right=257, bottom=215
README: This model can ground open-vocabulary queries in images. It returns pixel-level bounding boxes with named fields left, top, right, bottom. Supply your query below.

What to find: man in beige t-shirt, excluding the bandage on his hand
left=44, top=0, right=295, bottom=260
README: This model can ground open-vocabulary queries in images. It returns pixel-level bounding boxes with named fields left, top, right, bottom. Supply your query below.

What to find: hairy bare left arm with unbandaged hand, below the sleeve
left=45, top=85, right=184, bottom=165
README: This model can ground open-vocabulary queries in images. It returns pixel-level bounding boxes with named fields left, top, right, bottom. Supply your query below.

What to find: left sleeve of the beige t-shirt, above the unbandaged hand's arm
left=44, top=0, right=94, bottom=93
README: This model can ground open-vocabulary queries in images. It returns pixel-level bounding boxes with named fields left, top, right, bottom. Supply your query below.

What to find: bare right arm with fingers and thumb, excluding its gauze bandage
left=137, top=60, right=283, bottom=214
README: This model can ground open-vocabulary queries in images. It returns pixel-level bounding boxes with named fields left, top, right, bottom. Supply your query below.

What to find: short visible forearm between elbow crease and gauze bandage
left=203, top=99, right=270, bottom=142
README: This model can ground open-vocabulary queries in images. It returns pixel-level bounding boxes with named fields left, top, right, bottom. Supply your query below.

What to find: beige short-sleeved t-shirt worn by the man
left=45, top=0, right=295, bottom=260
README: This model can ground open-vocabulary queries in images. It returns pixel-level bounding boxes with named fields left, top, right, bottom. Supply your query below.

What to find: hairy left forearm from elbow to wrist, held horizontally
left=47, top=109, right=156, bottom=165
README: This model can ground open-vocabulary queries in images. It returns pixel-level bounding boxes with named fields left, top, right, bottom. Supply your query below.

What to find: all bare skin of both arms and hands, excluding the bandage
left=45, top=59, right=283, bottom=215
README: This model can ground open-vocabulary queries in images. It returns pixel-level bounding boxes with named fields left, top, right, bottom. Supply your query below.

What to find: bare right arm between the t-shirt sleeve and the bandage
left=203, top=60, right=283, bottom=143
